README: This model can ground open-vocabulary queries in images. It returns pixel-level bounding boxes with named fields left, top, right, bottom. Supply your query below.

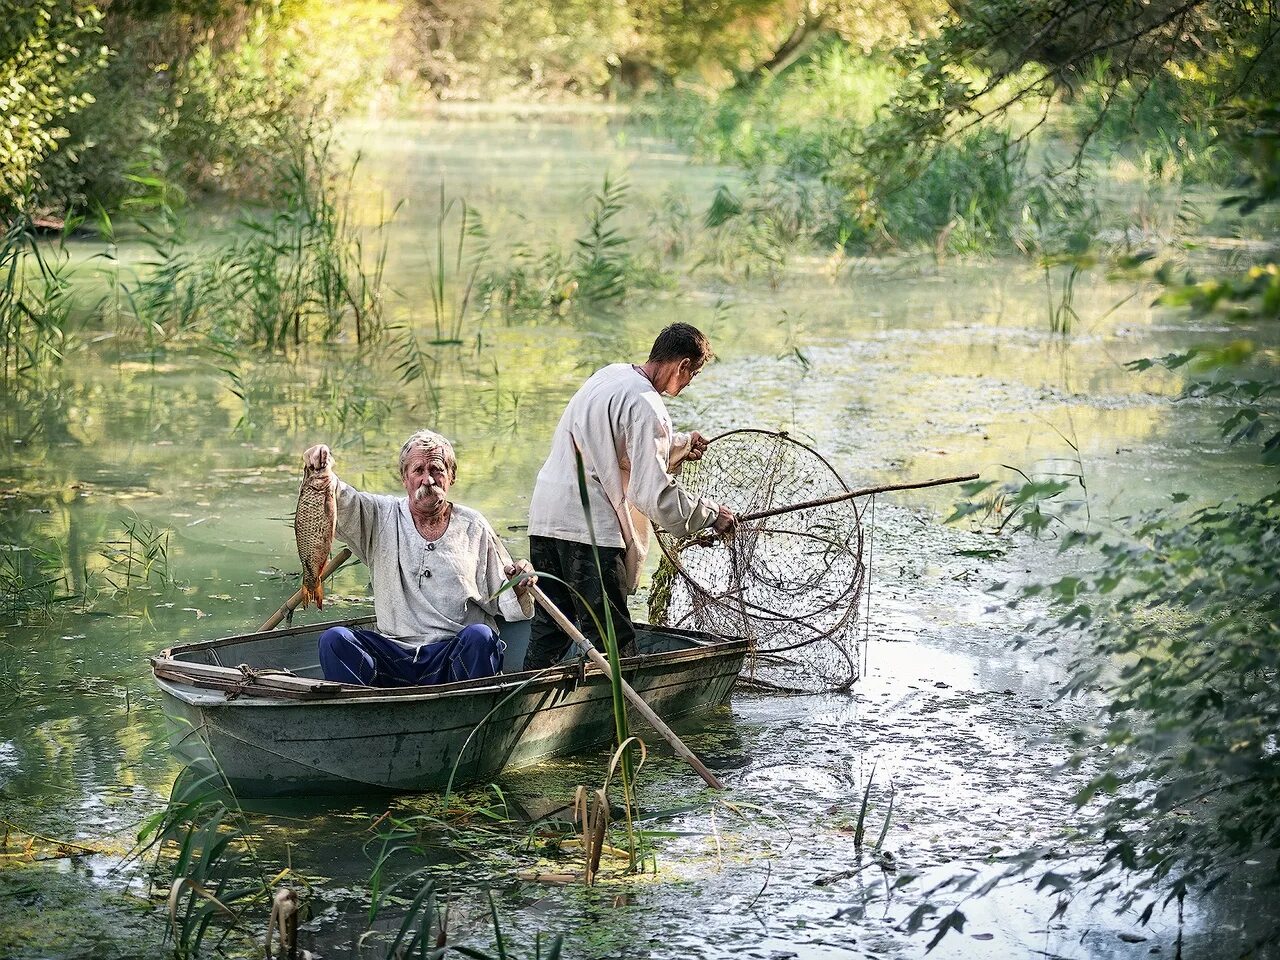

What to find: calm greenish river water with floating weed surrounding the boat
left=0, top=116, right=1275, bottom=960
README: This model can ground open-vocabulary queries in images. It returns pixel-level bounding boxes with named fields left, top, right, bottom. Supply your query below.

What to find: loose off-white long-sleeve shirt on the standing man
left=529, top=364, right=719, bottom=591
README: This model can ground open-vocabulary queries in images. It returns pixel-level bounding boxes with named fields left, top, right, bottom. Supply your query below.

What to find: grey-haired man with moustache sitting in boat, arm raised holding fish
left=300, top=430, right=534, bottom=686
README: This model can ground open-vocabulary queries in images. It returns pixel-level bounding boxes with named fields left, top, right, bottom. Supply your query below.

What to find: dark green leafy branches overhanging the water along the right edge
left=926, top=6, right=1280, bottom=950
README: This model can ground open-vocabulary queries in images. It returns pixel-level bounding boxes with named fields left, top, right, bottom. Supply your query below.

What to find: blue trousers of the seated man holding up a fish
left=320, top=623, right=507, bottom=686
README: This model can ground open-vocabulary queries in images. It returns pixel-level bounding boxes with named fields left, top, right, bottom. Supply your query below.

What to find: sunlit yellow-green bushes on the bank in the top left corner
left=0, top=0, right=397, bottom=220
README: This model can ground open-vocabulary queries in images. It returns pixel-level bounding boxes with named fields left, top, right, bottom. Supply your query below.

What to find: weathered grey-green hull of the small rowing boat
left=156, top=616, right=746, bottom=796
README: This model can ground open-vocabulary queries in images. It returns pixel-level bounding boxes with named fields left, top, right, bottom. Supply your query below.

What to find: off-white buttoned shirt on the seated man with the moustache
left=337, top=480, right=534, bottom=650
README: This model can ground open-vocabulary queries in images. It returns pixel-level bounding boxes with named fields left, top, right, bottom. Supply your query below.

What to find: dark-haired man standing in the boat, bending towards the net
left=525, top=324, right=733, bottom=669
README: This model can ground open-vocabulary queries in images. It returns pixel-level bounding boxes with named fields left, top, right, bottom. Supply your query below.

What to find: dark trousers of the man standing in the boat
left=525, top=536, right=636, bottom=669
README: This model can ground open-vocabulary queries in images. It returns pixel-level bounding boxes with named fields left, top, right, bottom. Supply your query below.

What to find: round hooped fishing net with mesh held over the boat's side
left=649, top=430, right=865, bottom=691
